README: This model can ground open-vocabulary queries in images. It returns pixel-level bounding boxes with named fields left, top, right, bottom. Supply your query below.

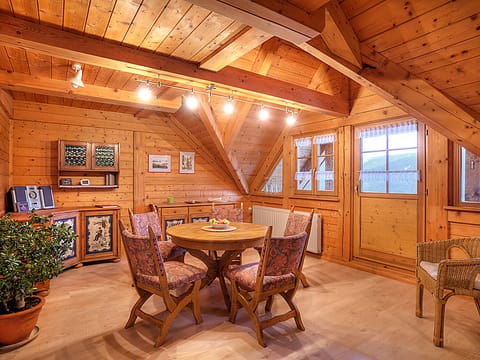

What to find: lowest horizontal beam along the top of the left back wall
left=0, top=70, right=182, bottom=113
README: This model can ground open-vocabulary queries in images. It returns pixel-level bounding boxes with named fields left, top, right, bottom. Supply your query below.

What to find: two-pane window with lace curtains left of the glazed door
left=294, top=133, right=336, bottom=194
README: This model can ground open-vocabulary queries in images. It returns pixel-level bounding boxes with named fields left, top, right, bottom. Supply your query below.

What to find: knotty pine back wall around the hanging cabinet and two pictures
left=11, top=101, right=244, bottom=223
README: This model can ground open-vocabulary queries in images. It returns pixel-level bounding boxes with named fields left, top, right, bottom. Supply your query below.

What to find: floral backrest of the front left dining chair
left=119, top=220, right=167, bottom=290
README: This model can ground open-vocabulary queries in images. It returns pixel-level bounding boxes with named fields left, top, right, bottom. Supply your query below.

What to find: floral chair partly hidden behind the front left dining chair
left=128, top=209, right=186, bottom=262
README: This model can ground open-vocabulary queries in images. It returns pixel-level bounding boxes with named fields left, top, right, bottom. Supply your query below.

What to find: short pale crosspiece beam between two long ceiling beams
left=200, top=26, right=273, bottom=71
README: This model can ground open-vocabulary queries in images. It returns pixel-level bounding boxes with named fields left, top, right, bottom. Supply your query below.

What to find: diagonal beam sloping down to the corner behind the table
left=198, top=100, right=248, bottom=194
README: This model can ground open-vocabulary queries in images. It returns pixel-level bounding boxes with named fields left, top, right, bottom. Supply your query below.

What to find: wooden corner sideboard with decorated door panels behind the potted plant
left=9, top=206, right=120, bottom=268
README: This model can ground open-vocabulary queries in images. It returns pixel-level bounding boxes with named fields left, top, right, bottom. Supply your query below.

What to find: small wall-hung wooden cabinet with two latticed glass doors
left=58, top=140, right=120, bottom=189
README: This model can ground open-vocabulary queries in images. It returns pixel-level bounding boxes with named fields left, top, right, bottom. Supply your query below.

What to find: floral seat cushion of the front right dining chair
left=225, top=263, right=295, bottom=291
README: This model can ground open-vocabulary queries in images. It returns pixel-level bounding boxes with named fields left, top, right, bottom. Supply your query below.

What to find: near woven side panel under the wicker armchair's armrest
left=437, top=258, right=480, bottom=291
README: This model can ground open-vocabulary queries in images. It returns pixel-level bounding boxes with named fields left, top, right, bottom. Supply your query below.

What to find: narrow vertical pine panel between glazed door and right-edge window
left=425, top=128, right=449, bottom=241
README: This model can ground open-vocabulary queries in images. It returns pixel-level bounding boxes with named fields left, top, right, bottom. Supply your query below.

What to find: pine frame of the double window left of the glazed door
left=291, top=129, right=339, bottom=197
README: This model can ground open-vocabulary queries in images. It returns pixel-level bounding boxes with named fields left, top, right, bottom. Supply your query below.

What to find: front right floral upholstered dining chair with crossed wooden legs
left=225, top=226, right=307, bottom=346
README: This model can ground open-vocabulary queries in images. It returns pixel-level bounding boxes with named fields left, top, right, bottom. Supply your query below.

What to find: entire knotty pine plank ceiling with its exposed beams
left=0, top=0, right=480, bottom=193
